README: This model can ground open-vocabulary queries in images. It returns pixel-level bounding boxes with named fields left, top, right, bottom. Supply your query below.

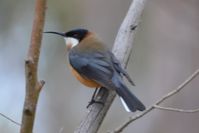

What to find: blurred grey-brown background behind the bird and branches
left=0, top=0, right=199, bottom=133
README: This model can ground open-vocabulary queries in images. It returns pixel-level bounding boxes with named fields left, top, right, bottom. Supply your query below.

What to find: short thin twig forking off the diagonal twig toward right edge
left=153, top=105, right=199, bottom=113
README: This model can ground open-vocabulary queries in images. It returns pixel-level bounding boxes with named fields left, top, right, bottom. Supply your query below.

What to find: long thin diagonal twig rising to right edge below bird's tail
left=111, top=69, right=199, bottom=133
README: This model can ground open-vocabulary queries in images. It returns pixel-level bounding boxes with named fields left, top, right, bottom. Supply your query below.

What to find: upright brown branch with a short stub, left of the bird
left=20, top=0, right=46, bottom=133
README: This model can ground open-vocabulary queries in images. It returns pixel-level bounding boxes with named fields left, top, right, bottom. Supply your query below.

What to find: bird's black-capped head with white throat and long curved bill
left=44, top=29, right=90, bottom=49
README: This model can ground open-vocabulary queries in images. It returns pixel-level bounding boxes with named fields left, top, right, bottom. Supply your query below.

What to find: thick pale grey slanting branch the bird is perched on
left=75, top=0, right=146, bottom=133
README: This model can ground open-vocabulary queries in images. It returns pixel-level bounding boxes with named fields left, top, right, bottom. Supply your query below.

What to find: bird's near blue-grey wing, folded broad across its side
left=69, top=51, right=114, bottom=87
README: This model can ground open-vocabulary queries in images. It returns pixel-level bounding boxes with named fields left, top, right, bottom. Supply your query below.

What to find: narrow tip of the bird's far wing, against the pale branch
left=109, top=52, right=135, bottom=86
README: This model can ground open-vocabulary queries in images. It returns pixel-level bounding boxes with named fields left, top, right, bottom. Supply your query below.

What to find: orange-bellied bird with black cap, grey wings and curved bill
left=44, top=28, right=145, bottom=112
